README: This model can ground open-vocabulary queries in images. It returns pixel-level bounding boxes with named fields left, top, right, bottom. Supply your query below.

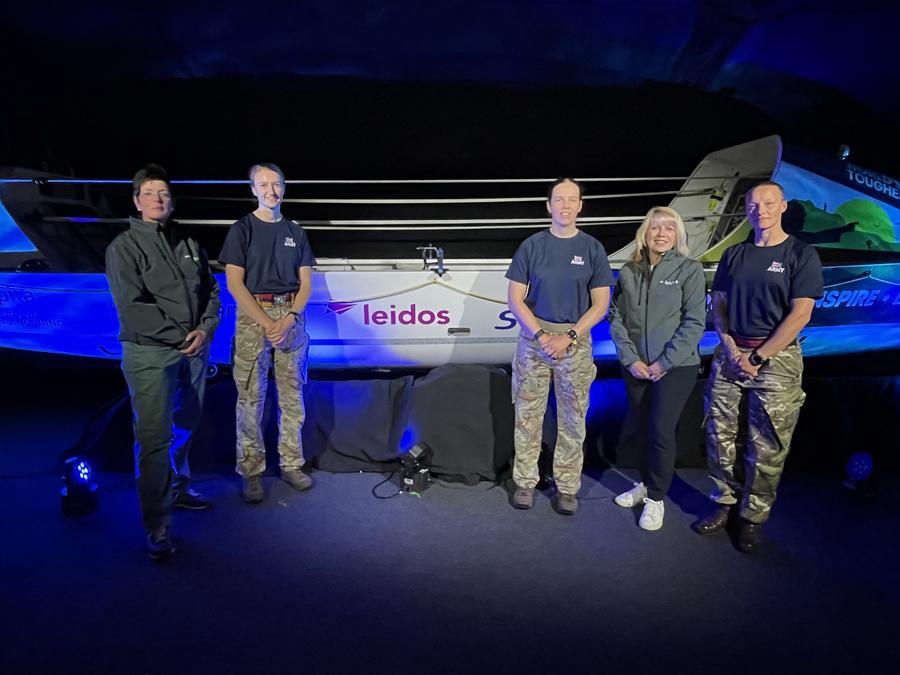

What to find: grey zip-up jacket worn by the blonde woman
left=609, top=250, right=706, bottom=370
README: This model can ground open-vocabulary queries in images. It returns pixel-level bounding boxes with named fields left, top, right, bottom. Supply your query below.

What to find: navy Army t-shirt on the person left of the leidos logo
left=219, top=213, right=316, bottom=293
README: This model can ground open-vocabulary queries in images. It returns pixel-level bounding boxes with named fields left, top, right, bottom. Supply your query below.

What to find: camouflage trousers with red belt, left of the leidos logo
left=232, top=306, right=309, bottom=477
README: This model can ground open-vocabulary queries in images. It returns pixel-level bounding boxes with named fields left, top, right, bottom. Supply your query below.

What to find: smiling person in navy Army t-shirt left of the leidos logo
left=219, top=164, right=316, bottom=504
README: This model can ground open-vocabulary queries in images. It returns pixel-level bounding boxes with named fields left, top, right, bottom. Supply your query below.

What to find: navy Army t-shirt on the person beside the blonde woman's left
left=506, top=230, right=613, bottom=323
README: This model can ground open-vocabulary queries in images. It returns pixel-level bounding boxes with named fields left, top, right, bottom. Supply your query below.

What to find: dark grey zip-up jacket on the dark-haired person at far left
left=106, top=217, right=221, bottom=349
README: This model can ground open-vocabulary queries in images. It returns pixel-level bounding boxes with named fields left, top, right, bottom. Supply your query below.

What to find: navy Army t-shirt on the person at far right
left=712, top=236, right=824, bottom=338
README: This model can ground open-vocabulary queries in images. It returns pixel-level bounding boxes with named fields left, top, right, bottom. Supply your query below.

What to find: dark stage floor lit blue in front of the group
left=0, top=362, right=900, bottom=673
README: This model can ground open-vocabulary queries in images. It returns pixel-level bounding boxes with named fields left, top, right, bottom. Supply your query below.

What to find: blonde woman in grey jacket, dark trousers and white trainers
left=609, top=206, right=706, bottom=530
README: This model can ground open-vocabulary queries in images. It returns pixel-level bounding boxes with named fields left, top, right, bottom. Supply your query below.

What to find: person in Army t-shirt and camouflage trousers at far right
left=696, top=182, right=823, bottom=553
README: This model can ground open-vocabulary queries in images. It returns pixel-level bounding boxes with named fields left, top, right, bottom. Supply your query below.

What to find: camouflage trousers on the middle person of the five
left=512, top=320, right=597, bottom=495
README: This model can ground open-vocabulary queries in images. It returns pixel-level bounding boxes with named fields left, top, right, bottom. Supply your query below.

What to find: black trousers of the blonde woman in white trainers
left=622, top=365, right=700, bottom=500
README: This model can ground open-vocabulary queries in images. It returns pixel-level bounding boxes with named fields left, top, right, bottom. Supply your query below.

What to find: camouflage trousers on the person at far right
left=705, top=344, right=806, bottom=523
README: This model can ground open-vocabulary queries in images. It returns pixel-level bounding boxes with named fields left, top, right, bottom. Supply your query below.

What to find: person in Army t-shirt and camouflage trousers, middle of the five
left=506, top=178, right=613, bottom=515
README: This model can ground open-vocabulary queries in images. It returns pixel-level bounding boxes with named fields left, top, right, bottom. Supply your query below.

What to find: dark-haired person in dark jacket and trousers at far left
left=106, top=164, right=220, bottom=560
